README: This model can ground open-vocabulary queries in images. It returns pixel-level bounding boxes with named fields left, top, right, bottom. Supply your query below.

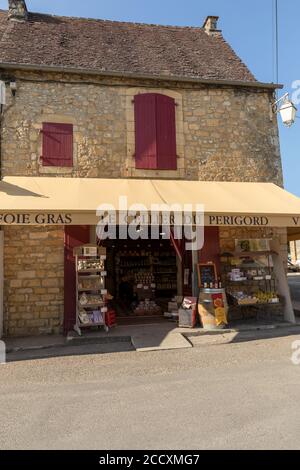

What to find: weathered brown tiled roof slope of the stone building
left=0, top=10, right=255, bottom=82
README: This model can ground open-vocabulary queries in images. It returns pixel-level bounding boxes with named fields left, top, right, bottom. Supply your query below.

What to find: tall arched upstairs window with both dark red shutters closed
left=134, top=93, right=177, bottom=170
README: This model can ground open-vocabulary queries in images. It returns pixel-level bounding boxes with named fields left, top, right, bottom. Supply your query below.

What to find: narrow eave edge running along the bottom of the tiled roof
left=0, top=63, right=284, bottom=90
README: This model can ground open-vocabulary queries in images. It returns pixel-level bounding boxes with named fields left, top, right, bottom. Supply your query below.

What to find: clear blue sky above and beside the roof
left=0, top=0, right=300, bottom=196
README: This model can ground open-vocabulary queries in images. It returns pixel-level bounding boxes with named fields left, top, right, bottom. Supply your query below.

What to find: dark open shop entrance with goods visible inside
left=101, top=235, right=181, bottom=324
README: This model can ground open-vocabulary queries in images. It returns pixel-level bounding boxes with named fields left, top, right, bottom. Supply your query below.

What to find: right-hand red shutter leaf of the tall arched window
left=156, top=94, right=177, bottom=170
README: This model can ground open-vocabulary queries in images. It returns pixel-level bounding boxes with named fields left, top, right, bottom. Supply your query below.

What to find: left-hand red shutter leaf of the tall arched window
left=134, top=93, right=157, bottom=170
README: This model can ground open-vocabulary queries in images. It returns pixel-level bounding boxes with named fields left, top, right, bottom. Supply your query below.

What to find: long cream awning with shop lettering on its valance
left=0, top=177, right=300, bottom=229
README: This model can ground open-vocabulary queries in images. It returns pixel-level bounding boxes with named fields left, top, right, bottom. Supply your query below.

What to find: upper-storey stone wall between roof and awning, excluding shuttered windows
left=2, top=72, right=282, bottom=185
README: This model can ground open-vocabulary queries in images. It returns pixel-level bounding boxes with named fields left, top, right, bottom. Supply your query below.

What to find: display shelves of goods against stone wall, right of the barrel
left=221, top=239, right=294, bottom=321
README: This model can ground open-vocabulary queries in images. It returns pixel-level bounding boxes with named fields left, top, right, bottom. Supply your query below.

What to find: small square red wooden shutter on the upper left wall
left=42, top=122, right=73, bottom=166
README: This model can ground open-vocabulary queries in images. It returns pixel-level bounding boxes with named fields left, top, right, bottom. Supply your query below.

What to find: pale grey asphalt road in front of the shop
left=0, top=329, right=300, bottom=449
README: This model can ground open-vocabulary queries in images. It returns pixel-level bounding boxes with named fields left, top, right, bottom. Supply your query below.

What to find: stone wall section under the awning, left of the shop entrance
left=4, top=227, right=64, bottom=336
